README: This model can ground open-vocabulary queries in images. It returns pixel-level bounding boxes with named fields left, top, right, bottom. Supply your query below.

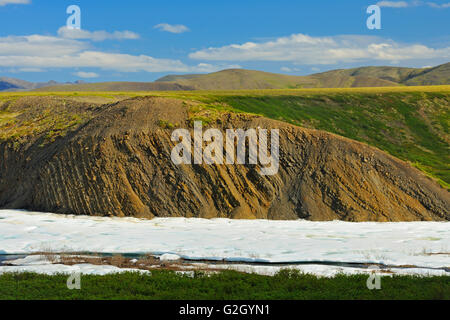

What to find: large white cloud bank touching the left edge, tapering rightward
left=0, top=35, right=236, bottom=72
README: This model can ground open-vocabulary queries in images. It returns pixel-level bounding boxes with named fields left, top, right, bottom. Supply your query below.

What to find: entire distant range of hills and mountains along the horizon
left=0, top=63, right=450, bottom=91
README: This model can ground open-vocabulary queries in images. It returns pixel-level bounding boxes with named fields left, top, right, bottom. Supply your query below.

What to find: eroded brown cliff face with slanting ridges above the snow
left=0, top=97, right=450, bottom=221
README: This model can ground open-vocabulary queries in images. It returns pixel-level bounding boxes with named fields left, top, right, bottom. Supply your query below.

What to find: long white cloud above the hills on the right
left=189, top=34, right=450, bottom=65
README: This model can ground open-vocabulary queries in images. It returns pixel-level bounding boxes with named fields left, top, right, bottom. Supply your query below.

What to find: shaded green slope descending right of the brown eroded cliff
left=212, top=92, right=450, bottom=188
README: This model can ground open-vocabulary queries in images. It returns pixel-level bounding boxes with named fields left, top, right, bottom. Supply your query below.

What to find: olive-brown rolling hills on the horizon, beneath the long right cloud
left=156, top=63, right=450, bottom=90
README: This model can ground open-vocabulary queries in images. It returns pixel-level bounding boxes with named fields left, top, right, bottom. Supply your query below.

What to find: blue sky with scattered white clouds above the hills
left=0, top=0, right=450, bottom=81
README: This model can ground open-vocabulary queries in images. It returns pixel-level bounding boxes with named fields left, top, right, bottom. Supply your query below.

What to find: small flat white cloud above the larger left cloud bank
left=58, top=26, right=139, bottom=41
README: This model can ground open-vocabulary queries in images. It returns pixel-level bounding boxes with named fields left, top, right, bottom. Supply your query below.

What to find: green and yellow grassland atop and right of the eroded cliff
left=0, top=85, right=450, bottom=188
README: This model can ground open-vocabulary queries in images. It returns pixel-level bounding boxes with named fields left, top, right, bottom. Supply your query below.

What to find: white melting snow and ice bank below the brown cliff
left=0, top=210, right=450, bottom=275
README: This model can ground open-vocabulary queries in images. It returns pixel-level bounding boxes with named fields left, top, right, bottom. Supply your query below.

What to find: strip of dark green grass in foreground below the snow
left=0, top=270, right=450, bottom=300
